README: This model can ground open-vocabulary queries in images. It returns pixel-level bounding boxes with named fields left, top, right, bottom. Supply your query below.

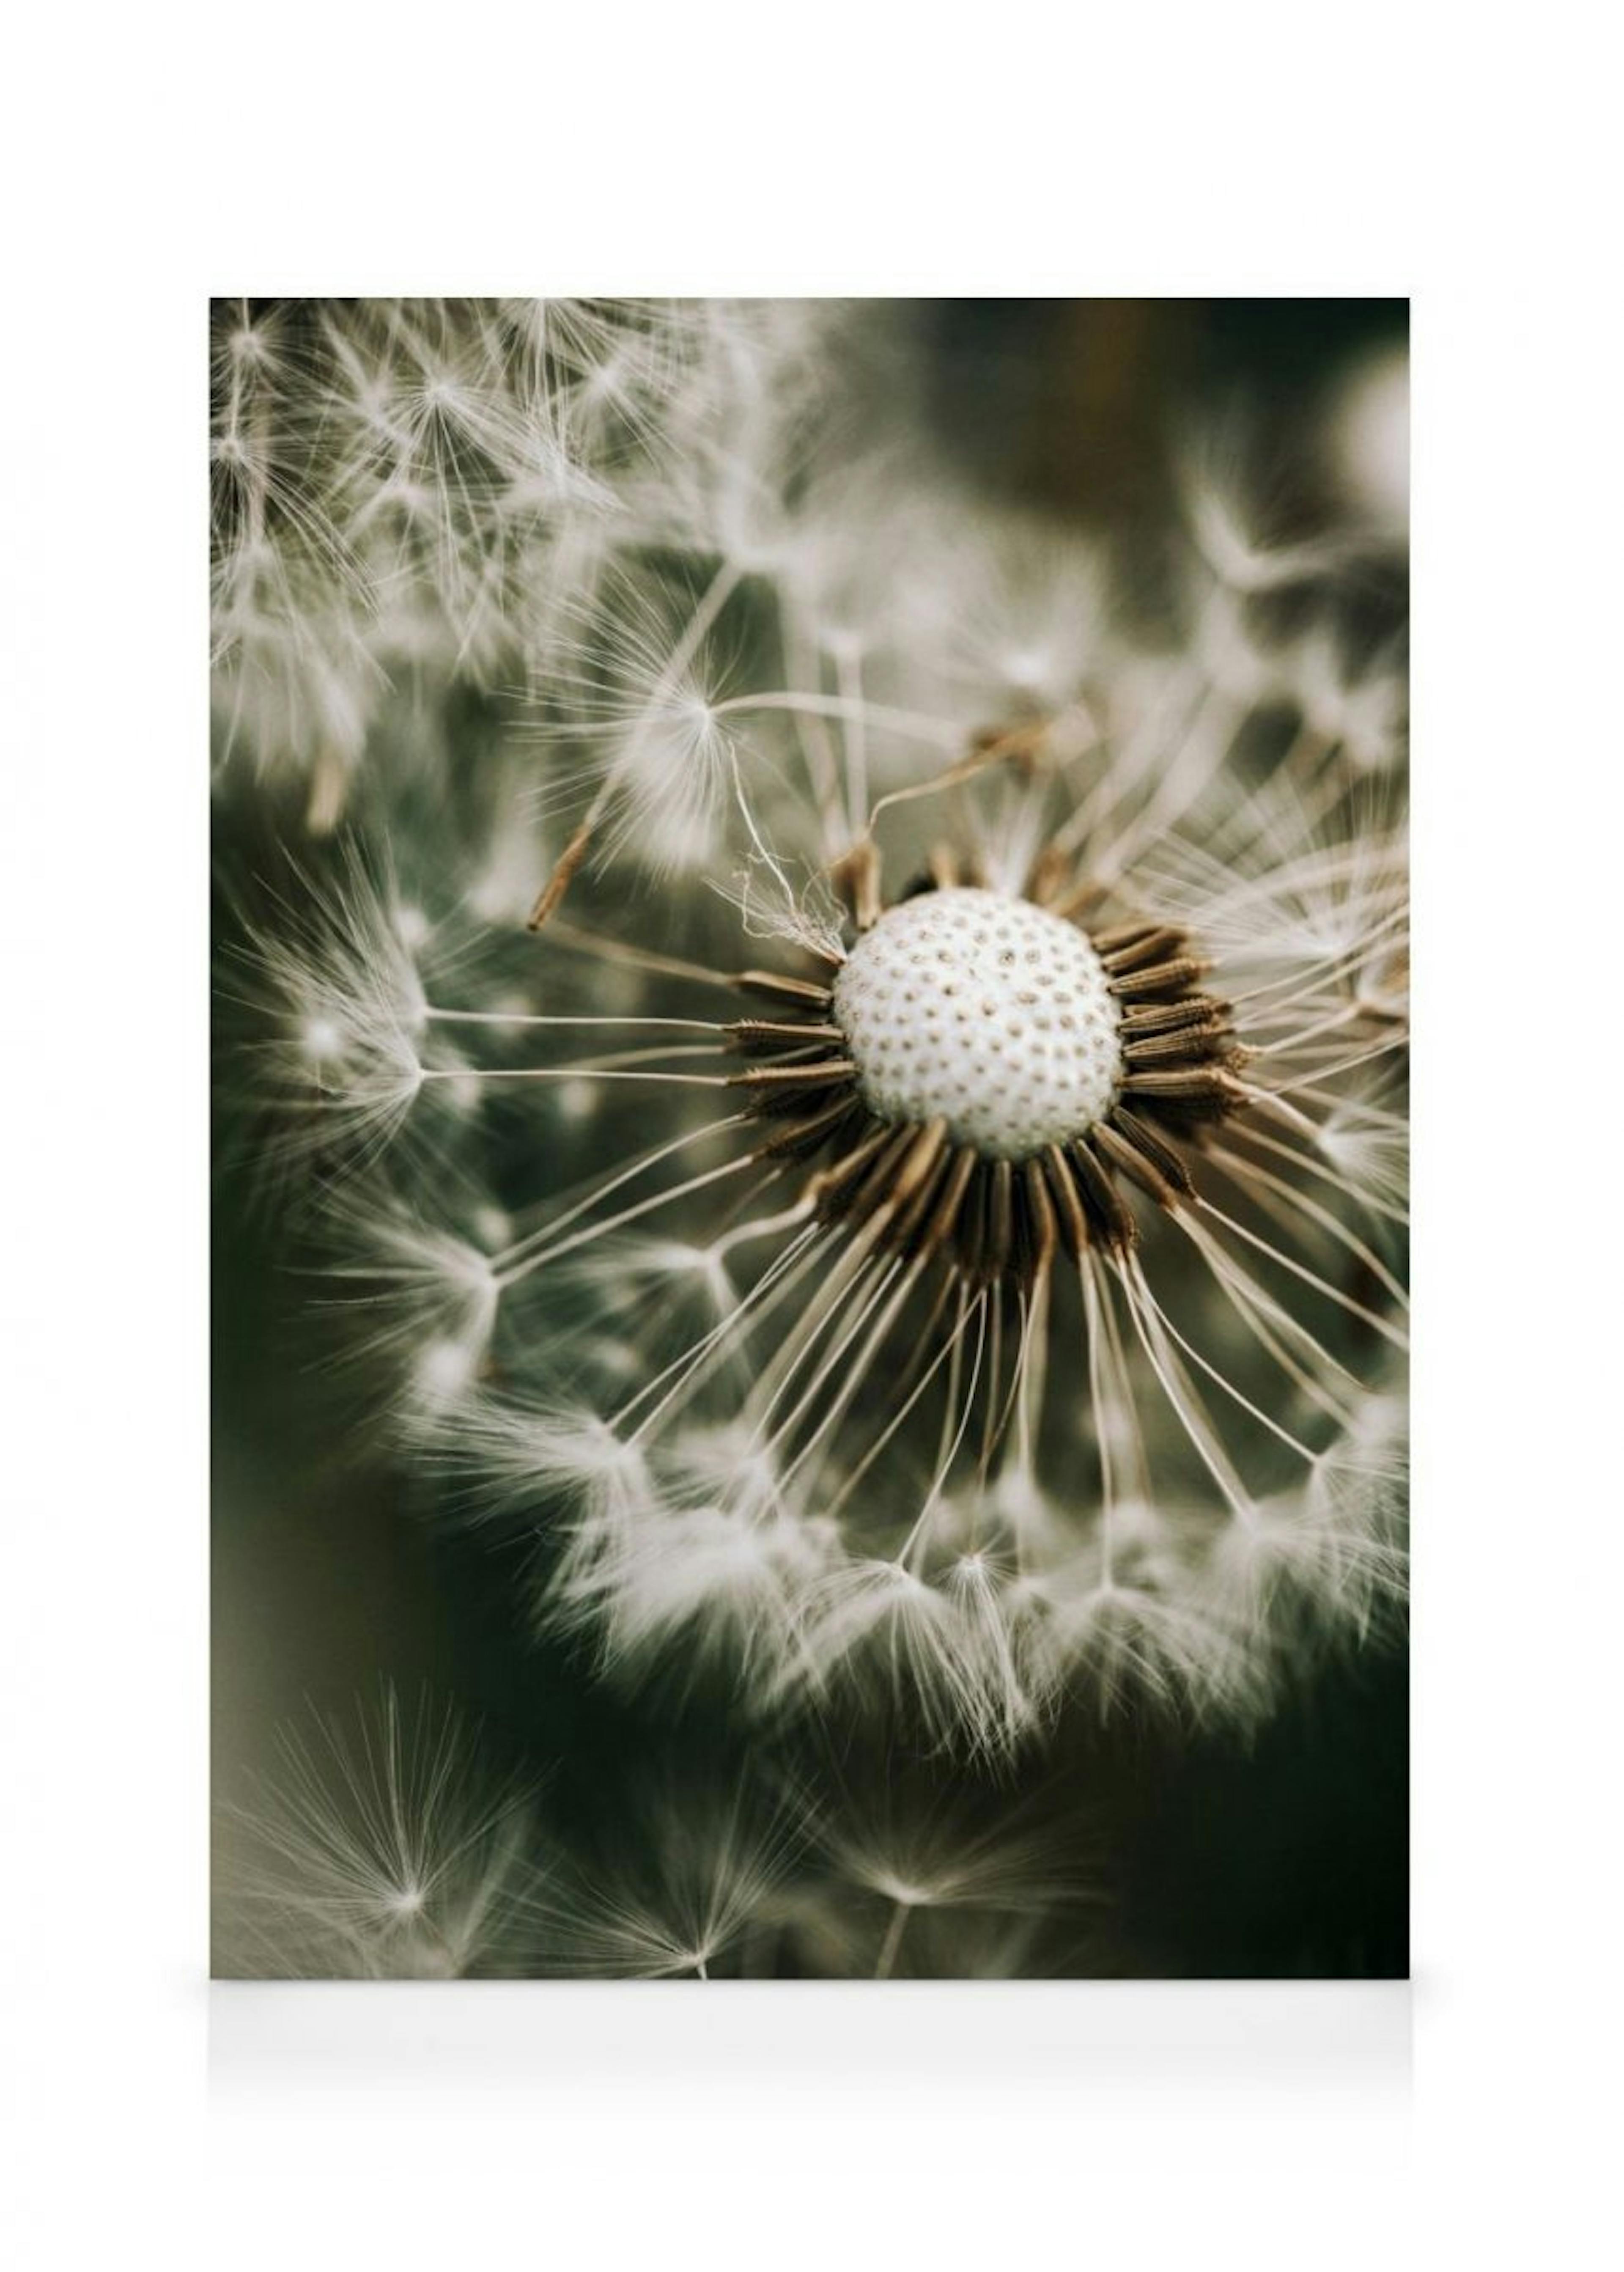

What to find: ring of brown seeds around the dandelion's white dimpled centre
left=727, top=852, right=1251, bottom=1286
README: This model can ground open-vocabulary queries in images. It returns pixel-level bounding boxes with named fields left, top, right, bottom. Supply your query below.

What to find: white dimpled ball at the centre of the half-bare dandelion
left=834, top=890, right=1122, bottom=1159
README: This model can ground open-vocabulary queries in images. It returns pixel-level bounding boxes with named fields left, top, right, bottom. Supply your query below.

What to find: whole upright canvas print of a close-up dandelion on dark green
left=212, top=298, right=1408, bottom=1984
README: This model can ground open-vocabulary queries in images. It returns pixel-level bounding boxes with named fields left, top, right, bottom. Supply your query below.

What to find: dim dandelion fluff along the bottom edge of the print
left=218, top=1686, right=1102, bottom=1981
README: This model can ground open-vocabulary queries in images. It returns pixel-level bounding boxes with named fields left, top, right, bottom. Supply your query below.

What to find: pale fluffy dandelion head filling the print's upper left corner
left=209, top=300, right=831, bottom=829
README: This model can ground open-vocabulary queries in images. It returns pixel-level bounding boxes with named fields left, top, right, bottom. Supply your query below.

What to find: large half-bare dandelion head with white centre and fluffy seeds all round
left=219, top=297, right=1406, bottom=1772
